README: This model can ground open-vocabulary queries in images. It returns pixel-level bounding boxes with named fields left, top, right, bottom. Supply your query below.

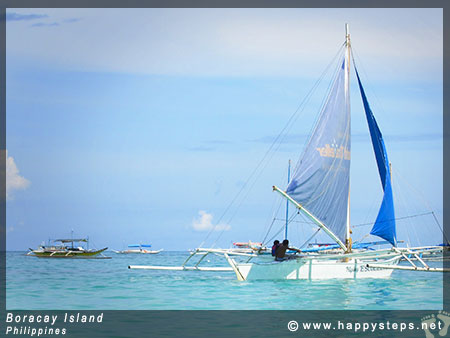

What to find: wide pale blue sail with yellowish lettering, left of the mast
left=286, top=57, right=350, bottom=242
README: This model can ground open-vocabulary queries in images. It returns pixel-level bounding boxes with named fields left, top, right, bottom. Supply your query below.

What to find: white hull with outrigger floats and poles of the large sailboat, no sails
left=128, top=246, right=450, bottom=281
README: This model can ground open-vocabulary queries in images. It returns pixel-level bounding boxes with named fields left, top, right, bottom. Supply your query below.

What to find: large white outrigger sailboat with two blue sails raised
left=129, top=25, right=447, bottom=281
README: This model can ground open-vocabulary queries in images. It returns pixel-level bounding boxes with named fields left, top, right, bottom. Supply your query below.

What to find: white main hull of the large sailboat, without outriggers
left=235, top=257, right=400, bottom=280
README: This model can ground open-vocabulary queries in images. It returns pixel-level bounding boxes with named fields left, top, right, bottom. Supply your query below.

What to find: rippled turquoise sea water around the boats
left=6, top=251, right=444, bottom=310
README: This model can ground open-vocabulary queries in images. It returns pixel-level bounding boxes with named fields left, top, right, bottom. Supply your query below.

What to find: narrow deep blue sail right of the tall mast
left=355, top=67, right=397, bottom=246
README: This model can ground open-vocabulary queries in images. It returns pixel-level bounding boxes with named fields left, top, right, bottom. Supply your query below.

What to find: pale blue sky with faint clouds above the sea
left=7, top=9, right=442, bottom=250
